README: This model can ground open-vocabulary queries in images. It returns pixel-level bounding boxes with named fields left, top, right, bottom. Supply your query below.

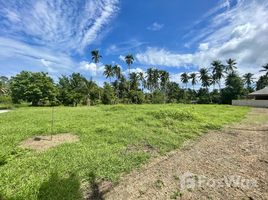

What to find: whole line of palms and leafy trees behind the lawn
left=0, top=50, right=268, bottom=106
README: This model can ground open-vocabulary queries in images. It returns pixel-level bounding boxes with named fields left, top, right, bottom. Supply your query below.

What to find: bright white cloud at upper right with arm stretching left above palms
left=136, top=0, right=268, bottom=76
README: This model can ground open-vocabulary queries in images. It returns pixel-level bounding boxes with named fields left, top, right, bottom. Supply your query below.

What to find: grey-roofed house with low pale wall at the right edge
left=232, top=86, right=268, bottom=108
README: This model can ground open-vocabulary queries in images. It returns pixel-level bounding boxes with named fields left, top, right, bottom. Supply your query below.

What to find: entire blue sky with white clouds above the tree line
left=0, top=0, right=268, bottom=84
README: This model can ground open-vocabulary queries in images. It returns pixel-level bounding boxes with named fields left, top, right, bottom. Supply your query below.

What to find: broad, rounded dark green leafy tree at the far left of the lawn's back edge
left=10, top=71, right=57, bottom=106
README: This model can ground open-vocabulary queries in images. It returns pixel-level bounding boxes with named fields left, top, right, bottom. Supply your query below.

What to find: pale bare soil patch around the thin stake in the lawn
left=20, top=133, right=79, bottom=152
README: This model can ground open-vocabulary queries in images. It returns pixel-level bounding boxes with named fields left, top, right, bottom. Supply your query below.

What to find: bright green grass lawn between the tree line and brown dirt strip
left=0, top=104, right=249, bottom=200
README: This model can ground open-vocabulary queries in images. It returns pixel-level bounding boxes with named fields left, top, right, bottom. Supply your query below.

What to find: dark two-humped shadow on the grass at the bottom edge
left=37, top=173, right=83, bottom=200
